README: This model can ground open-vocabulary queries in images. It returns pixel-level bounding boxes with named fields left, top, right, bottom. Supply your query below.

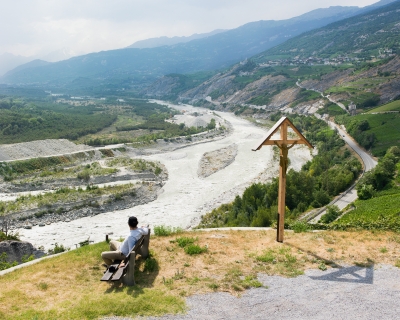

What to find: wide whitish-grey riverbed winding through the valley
left=14, top=105, right=311, bottom=249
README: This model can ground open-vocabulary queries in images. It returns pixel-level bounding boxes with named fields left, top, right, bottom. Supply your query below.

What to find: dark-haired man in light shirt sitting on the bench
left=101, top=217, right=149, bottom=266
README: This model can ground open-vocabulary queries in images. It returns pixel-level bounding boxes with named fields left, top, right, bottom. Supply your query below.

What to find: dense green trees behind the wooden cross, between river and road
left=200, top=116, right=361, bottom=227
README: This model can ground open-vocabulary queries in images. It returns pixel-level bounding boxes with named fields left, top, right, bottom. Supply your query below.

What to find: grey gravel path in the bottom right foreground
left=105, top=265, right=400, bottom=320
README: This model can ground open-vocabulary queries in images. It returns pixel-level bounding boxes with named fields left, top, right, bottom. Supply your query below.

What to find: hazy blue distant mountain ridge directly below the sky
left=1, top=0, right=396, bottom=88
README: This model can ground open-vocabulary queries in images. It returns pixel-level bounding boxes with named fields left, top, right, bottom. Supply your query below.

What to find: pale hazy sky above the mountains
left=0, top=0, right=378, bottom=56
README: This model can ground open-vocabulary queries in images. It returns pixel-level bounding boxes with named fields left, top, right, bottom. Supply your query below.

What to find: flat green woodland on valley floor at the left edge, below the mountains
left=0, top=98, right=116, bottom=144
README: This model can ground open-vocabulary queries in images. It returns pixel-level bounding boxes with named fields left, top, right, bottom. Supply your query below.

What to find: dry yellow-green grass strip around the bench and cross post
left=0, top=230, right=400, bottom=319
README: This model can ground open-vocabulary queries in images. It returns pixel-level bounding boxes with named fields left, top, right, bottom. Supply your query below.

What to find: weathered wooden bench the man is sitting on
left=100, top=229, right=150, bottom=286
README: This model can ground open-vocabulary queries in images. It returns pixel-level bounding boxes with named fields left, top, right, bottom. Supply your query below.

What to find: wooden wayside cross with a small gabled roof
left=253, top=117, right=314, bottom=242
